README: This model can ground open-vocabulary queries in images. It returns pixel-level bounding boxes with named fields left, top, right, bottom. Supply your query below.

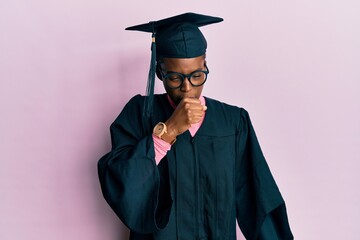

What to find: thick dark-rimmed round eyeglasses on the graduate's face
left=159, top=64, right=209, bottom=89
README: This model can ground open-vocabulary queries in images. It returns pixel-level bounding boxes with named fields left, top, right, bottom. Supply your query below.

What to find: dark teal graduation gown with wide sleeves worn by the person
left=98, top=94, right=293, bottom=240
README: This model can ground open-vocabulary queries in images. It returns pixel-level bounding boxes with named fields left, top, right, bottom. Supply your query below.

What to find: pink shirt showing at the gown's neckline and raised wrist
left=152, top=95, right=206, bottom=164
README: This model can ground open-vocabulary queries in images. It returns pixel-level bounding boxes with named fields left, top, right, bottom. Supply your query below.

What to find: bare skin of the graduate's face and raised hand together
left=157, top=56, right=207, bottom=142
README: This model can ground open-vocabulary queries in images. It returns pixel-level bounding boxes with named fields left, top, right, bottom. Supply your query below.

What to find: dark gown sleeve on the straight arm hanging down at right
left=235, top=109, right=293, bottom=240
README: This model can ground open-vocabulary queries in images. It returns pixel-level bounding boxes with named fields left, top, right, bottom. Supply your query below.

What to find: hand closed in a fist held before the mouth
left=165, top=98, right=207, bottom=138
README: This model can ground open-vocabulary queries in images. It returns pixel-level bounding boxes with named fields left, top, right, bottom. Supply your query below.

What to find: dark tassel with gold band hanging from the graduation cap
left=143, top=22, right=156, bottom=129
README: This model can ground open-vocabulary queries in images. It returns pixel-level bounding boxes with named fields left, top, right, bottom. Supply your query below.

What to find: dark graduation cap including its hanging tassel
left=125, top=13, right=223, bottom=122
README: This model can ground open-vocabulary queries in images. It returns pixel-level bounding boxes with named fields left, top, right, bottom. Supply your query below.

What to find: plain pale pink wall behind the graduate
left=0, top=0, right=360, bottom=240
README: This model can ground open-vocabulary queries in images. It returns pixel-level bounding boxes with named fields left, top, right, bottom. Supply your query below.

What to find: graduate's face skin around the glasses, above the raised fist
left=158, top=56, right=206, bottom=105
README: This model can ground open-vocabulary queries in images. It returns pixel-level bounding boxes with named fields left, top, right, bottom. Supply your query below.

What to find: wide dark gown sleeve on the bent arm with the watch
left=98, top=95, right=172, bottom=234
